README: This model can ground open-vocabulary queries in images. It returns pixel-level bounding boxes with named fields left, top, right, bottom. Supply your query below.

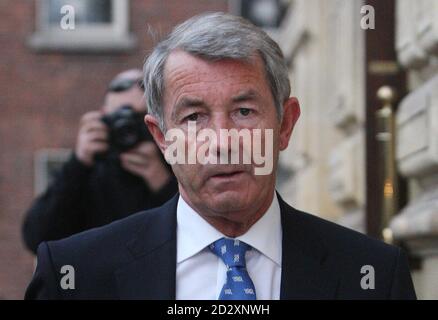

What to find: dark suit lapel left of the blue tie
left=115, top=194, right=178, bottom=299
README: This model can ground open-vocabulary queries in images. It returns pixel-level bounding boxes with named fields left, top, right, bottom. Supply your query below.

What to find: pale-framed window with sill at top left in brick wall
left=29, top=0, right=136, bottom=52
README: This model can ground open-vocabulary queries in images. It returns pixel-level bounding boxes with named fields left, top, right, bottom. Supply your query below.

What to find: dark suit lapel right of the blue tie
left=278, top=195, right=338, bottom=300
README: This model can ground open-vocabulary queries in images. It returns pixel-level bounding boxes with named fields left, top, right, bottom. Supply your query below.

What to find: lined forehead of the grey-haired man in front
left=164, top=50, right=271, bottom=115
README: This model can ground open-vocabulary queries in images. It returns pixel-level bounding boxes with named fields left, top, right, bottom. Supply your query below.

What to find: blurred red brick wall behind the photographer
left=0, top=0, right=228, bottom=299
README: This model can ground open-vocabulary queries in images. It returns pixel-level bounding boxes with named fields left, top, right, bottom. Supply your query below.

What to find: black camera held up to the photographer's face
left=101, top=105, right=153, bottom=154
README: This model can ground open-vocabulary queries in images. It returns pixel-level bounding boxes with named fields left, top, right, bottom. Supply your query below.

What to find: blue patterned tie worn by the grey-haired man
left=209, top=238, right=256, bottom=300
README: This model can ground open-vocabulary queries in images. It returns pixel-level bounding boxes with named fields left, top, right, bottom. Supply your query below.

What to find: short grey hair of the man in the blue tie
left=143, top=12, right=290, bottom=132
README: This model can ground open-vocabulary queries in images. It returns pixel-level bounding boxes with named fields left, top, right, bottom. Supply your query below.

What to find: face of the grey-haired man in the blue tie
left=149, top=51, right=298, bottom=225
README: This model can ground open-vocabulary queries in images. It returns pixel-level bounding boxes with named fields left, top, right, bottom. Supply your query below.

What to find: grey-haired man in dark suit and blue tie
left=26, top=13, right=415, bottom=299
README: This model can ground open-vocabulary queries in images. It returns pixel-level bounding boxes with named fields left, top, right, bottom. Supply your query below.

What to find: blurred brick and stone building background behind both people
left=0, top=0, right=438, bottom=299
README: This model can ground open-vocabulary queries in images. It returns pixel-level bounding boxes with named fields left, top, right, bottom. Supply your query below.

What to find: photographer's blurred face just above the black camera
left=102, top=86, right=146, bottom=114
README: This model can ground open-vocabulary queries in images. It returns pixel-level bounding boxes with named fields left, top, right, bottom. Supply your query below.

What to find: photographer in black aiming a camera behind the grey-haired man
left=23, top=70, right=177, bottom=253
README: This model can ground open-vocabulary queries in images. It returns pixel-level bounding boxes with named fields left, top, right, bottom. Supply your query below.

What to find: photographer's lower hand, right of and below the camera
left=120, top=142, right=171, bottom=192
